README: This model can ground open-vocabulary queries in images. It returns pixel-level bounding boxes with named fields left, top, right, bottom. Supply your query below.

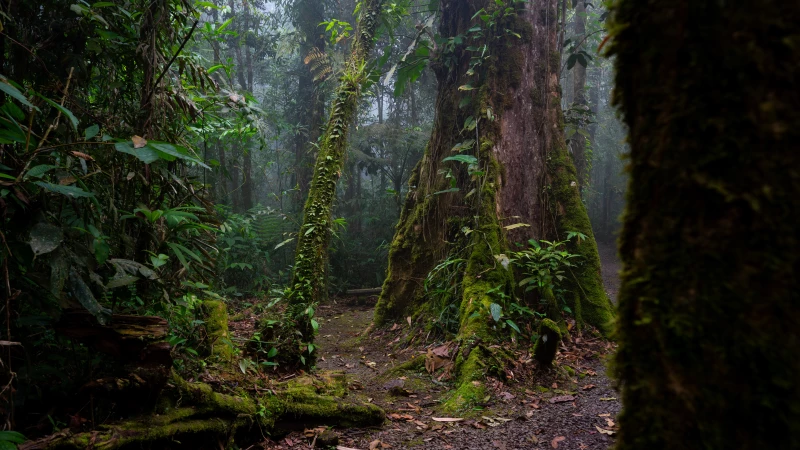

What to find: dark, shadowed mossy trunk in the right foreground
left=612, top=0, right=800, bottom=450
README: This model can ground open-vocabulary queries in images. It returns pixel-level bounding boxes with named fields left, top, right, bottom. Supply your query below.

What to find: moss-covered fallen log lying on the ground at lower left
left=20, top=373, right=385, bottom=450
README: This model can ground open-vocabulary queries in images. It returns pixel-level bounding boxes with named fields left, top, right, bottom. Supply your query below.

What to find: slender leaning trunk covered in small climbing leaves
left=287, top=0, right=382, bottom=348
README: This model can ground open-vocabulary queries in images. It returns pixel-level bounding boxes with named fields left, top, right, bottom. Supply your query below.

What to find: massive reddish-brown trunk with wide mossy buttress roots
left=375, top=0, right=613, bottom=412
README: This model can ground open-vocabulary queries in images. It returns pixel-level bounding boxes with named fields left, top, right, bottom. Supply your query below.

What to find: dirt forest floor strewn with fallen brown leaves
left=232, top=245, right=620, bottom=450
